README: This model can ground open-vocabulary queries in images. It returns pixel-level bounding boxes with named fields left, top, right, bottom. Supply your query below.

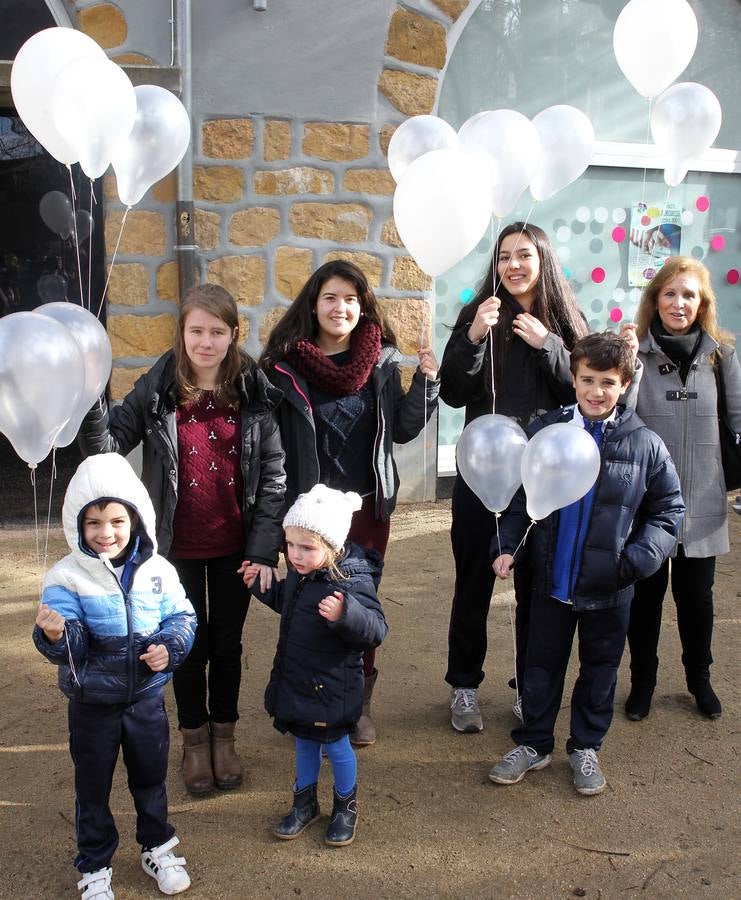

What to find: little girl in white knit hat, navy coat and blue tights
left=243, top=484, right=388, bottom=847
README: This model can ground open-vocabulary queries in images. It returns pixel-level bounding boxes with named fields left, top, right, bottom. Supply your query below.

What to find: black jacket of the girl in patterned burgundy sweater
left=78, top=350, right=285, bottom=566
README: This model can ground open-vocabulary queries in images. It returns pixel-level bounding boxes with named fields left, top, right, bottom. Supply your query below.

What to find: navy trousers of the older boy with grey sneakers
left=512, top=595, right=630, bottom=754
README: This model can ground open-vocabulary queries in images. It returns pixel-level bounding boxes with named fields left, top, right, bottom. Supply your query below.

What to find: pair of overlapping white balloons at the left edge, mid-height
left=0, top=301, right=111, bottom=468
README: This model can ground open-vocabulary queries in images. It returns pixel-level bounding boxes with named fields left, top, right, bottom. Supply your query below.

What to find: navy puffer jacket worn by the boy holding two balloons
left=491, top=406, right=684, bottom=610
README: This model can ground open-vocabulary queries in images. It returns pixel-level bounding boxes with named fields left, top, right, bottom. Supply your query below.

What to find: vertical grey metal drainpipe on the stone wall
left=173, top=0, right=198, bottom=299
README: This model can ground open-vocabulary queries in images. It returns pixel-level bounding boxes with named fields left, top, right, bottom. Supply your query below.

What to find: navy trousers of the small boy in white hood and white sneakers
left=68, top=690, right=175, bottom=872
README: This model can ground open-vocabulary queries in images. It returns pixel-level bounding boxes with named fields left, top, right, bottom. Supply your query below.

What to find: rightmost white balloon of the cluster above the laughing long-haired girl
left=530, top=104, right=595, bottom=200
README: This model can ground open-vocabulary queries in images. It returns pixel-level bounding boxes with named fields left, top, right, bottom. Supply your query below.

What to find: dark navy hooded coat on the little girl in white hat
left=252, top=543, right=388, bottom=742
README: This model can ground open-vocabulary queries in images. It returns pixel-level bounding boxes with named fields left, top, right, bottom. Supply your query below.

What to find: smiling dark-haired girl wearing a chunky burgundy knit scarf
left=260, top=260, right=438, bottom=746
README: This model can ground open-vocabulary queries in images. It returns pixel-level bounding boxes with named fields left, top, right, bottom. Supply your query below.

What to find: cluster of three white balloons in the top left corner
left=10, top=28, right=190, bottom=206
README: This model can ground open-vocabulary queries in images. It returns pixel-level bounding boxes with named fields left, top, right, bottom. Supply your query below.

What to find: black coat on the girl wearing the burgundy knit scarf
left=267, top=344, right=439, bottom=521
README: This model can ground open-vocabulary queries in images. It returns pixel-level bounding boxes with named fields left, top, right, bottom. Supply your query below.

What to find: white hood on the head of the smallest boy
left=62, top=453, right=157, bottom=559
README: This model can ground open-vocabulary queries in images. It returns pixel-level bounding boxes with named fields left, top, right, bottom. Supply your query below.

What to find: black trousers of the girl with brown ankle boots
left=170, top=554, right=250, bottom=728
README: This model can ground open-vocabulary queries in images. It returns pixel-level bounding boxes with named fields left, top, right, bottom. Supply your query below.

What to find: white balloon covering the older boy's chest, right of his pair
left=522, top=422, right=600, bottom=522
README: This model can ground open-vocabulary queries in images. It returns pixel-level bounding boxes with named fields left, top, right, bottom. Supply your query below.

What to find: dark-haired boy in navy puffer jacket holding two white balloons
left=489, top=332, right=684, bottom=795
